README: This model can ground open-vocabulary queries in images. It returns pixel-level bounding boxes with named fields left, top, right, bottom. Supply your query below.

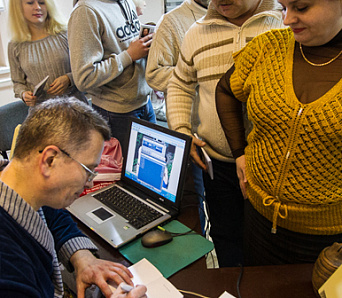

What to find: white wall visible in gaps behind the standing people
left=0, top=0, right=164, bottom=106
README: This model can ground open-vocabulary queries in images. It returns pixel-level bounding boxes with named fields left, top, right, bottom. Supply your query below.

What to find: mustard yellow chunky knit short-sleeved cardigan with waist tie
left=230, top=29, right=342, bottom=235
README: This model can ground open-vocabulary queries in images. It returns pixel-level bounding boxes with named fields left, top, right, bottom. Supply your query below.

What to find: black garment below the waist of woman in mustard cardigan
left=244, top=200, right=342, bottom=266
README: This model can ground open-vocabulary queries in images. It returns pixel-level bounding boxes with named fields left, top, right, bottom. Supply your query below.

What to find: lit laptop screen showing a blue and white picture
left=124, top=121, right=186, bottom=202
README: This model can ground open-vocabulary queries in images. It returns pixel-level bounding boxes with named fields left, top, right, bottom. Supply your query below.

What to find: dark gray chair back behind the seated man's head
left=0, top=101, right=29, bottom=159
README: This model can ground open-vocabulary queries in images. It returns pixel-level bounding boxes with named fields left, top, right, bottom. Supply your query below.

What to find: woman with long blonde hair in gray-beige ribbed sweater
left=8, top=0, right=86, bottom=106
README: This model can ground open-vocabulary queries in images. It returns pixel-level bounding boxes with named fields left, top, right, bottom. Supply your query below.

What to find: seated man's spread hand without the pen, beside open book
left=70, top=250, right=133, bottom=298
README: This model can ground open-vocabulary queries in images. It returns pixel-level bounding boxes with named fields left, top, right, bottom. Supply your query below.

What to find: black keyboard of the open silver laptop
left=94, top=187, right=163, bottom=229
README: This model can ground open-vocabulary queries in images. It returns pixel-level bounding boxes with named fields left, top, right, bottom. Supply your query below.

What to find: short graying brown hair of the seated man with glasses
left=13, top=97, right=111, bottom=159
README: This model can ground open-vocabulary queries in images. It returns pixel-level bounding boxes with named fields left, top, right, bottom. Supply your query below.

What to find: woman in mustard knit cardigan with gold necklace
left=216, top=0, right=342, bottom=265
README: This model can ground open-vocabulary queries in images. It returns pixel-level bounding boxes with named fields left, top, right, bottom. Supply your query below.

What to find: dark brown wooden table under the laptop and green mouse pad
left=63, top=171, right=317, bottom=298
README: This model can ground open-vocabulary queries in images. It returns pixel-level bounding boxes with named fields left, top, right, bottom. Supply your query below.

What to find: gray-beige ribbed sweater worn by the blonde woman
left=8, top=32, right=84, bottom=102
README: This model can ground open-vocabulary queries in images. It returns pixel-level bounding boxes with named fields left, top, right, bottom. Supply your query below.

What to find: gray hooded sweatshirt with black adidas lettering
left=68, top=0, right=151, bottom=113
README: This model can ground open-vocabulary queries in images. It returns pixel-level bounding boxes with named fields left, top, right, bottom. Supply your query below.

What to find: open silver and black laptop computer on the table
left=67, top=118, right=192, bottom=248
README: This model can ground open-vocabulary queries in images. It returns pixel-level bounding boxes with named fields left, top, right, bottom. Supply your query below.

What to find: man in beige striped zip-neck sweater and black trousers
left=167, top=0, right=283, bottom=267
